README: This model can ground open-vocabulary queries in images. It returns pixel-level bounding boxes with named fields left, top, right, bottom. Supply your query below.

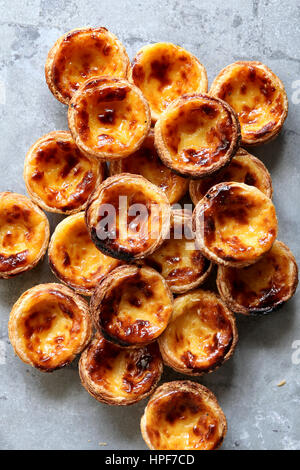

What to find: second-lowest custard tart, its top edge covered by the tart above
left=79, top=333, right=163, bottom=405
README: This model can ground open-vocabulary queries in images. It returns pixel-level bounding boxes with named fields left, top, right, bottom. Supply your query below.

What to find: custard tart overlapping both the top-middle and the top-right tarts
left=155, top=93, right=240, bottom=178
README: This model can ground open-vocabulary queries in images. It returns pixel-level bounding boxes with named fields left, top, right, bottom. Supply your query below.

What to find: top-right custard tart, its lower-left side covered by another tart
left=209, top=61, right=288, bottom=145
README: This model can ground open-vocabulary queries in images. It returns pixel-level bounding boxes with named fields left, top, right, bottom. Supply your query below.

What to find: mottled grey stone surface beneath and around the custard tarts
left=0, top=0, right=300, bottom=449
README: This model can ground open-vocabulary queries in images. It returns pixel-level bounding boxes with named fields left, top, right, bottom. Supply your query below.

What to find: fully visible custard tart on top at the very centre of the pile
left=86, top=173, right=171, bottom=261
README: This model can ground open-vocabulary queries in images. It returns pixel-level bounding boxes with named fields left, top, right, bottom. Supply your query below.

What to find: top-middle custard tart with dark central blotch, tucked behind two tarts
left=129, top=42, right=207, bottom=121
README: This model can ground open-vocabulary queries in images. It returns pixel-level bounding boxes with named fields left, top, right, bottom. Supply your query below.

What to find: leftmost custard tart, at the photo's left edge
left=0, top=191, right=50, bottom=279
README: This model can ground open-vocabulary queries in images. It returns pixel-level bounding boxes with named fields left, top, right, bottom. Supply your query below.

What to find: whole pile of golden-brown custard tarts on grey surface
left=0, top=28, right=298, bottom=449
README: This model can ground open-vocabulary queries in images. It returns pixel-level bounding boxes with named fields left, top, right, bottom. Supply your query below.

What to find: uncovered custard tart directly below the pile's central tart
left=91, top=265, right=173, bottom=348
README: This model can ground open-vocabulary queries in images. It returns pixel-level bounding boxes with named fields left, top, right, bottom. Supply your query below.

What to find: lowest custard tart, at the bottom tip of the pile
left=141, top=380, right=227, bottom=450
